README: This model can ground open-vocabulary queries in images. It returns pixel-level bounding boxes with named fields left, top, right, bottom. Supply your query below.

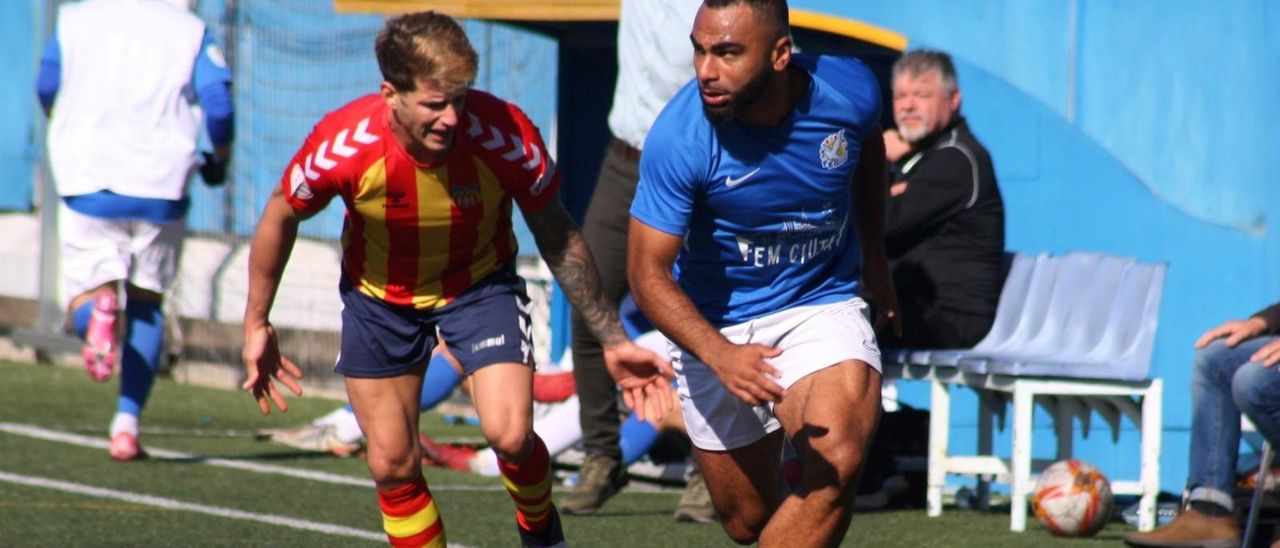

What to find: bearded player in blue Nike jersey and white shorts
left=616, top=0, right=900, bottom=545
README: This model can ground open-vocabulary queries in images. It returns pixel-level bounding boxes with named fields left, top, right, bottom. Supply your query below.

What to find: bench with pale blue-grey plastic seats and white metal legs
left=882, top=252, right=1166, bottom=531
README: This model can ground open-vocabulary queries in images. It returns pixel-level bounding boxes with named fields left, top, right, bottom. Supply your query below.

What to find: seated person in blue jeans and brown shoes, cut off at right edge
left=1124, top=303, right=1280, bottom=548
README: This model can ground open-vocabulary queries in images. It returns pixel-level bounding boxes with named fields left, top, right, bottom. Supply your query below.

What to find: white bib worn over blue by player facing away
left=49, top=0, right=205, bottom=200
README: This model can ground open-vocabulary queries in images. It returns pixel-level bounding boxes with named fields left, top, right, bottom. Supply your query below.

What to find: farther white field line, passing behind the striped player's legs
left=0, top=423, right=506, bottom=492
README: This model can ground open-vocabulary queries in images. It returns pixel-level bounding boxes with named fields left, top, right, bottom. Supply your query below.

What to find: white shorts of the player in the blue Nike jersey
left=669, top=298, right=881, bottom=451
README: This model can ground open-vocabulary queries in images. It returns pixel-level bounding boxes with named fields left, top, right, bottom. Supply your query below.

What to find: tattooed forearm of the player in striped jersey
left=525, top=200, right=627, bottom=347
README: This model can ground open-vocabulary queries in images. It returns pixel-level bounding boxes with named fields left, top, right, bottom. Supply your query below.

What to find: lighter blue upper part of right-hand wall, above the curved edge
left=791, top=0, right=1280, bottom=230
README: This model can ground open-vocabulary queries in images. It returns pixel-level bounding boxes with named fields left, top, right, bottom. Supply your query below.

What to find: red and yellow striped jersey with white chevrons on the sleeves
left=280, top=90, right=559, bottom=309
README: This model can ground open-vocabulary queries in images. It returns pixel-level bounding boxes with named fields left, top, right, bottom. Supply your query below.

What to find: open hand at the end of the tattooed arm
left=604, top=341, right=676, bottom=421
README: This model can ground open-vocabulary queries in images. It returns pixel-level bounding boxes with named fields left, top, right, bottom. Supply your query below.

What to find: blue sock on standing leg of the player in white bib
left=117, top=300, right=164, bottom=416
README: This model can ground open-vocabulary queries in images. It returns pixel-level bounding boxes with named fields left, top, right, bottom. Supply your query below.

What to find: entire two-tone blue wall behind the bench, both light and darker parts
left=792, top=0, right=1280, bottom=493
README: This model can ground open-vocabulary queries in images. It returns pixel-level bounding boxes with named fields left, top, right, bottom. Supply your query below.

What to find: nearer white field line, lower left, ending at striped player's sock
left=0, top=470, right=387, bottom=543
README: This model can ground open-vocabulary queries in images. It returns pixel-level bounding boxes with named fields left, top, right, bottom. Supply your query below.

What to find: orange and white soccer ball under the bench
left=1032, top=460, right=1115, bottom=536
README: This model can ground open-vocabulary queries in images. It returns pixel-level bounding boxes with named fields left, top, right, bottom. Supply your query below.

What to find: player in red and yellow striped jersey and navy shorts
left=243, top=12, right=673, bottom=547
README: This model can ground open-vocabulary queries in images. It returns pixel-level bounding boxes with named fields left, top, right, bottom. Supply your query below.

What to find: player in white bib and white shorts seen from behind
left=36, top=0, right=234, bottom=461
